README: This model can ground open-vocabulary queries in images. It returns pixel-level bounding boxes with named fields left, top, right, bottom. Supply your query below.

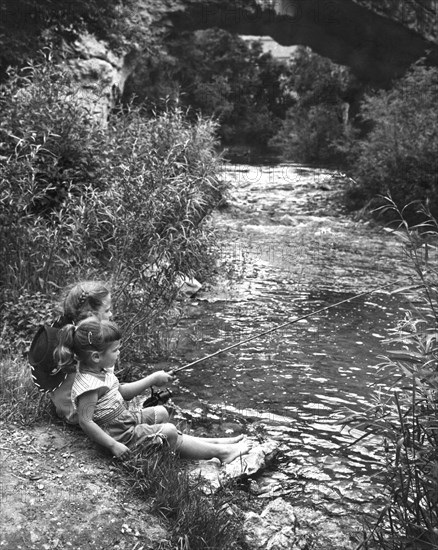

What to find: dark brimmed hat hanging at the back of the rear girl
left=28, top=325, right=67, bottom=392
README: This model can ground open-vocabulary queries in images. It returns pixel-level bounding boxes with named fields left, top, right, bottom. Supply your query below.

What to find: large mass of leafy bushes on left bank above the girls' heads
left=0, top=55, right=222, bottom=362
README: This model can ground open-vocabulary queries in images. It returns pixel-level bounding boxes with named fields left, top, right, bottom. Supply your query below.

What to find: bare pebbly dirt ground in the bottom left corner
left=0, top=423, right=167, bottom=550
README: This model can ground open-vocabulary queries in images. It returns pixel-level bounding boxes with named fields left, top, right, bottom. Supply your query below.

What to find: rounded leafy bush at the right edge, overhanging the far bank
left=346, top=63, right=438, bottom=221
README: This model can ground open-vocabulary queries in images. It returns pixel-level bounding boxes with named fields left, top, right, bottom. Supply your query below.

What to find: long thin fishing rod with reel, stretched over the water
left=143, top=281, right=410, bottom=406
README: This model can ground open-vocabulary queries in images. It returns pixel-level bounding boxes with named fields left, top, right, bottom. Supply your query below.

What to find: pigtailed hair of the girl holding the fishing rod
left=54, top=317, right=122, bottom=369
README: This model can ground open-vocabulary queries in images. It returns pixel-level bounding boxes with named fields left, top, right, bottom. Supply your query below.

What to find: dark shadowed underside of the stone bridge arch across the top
left=165, top=0, right=438, bottom=87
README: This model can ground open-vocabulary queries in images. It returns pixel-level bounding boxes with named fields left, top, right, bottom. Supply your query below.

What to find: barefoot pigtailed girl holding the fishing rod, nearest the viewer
left=55, top=317, right=248, bottom=463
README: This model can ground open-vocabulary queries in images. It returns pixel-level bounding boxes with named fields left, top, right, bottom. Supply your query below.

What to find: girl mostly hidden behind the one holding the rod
left=48, top=281, right=169, bottom=424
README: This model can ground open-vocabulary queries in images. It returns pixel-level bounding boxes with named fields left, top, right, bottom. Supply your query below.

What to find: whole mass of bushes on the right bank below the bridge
left=271, top=49, right=438, bottom=221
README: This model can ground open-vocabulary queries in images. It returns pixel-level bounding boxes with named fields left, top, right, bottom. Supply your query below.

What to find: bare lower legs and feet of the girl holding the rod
left=176, top=434, right=249, bottom=464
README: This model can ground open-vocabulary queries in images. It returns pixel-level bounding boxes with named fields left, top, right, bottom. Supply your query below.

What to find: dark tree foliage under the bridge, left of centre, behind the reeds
left=126, top=29, right=290, bottom=146
